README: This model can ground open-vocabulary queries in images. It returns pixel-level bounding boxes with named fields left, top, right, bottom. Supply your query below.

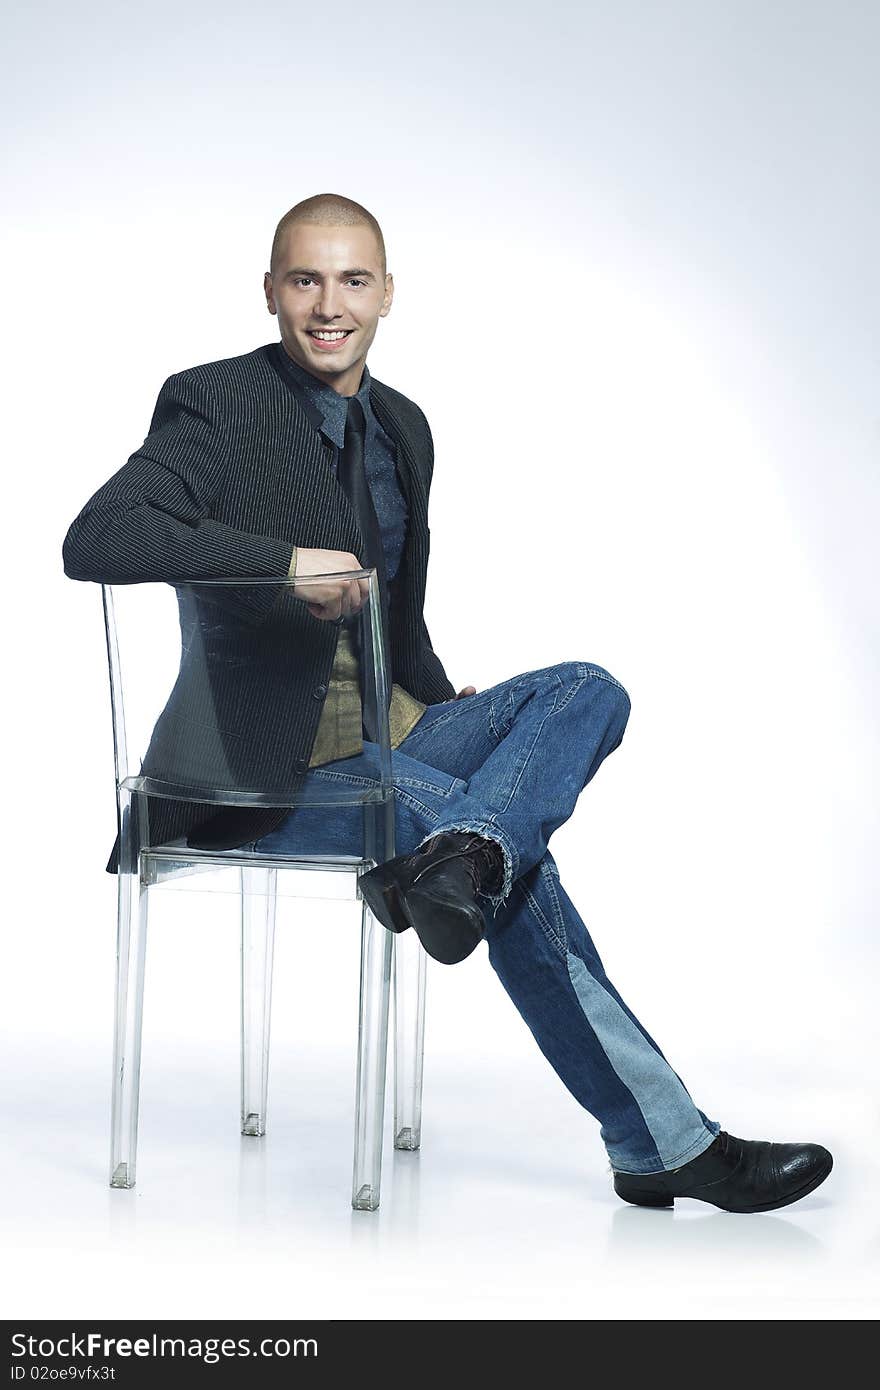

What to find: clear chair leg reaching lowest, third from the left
left=352, top=884, right=393, bottom=1211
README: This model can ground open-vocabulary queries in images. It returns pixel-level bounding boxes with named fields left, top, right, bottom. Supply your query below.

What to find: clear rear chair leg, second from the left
left=241, top=867, right=278, bottom=1136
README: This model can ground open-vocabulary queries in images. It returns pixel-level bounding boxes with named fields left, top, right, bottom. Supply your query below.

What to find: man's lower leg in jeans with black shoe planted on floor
left=484, top=849, right=833, bottom=1212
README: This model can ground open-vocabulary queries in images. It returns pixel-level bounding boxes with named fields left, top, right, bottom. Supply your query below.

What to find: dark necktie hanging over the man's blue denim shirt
left=336, top=396, right=392, bottom=742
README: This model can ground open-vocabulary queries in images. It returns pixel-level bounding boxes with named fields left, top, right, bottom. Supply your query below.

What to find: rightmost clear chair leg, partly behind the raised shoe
left=392, top=931, right=428, bottom=1150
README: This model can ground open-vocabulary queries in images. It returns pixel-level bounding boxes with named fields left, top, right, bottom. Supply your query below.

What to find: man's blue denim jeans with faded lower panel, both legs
left=248, top=662, right=720, bottom=1173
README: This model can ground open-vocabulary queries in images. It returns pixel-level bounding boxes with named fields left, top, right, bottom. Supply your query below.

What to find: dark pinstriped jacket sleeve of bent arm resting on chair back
left=63, top=371, right=293, bottom=589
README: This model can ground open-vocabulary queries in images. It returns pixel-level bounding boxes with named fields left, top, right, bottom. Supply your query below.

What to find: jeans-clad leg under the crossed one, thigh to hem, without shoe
left=246, top=733, right=717, bottom=1173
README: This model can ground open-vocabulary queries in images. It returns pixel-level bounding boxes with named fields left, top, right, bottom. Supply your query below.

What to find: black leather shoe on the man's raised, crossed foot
left=359, top=830, right=503, bottom=965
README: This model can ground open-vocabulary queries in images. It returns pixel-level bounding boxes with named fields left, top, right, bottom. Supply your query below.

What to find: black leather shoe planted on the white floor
left=613, top=1130, right=834, bottom=1212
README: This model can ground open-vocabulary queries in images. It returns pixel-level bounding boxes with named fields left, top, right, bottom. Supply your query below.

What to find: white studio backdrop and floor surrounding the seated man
left=0, top=0, right=880, bottom=1319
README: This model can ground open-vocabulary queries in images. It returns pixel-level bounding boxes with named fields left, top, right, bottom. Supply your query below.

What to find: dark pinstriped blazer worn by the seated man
left=63, top=343, right=455, bottom=873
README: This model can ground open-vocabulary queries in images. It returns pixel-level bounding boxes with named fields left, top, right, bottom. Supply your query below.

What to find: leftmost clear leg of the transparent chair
left=110, top=794, right=149, bottom=1187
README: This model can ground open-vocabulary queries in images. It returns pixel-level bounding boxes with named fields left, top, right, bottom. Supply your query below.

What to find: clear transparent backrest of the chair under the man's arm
left=101, top=569, right=391, bottom=806
